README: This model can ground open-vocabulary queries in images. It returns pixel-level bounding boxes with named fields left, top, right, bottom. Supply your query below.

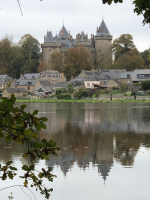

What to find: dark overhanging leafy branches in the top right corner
left=102, top=0, right=150, bottom=24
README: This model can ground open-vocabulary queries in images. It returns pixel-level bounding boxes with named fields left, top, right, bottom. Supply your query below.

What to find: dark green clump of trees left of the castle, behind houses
left=0, top=34, right=41, bottom=78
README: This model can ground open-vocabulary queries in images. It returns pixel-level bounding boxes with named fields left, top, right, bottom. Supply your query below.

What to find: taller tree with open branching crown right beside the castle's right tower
left=112, top=34, right=137, bottom=60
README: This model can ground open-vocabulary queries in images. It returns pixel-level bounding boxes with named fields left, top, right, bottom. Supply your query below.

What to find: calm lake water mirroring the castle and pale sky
left=0, top=103, right=150, bottom=200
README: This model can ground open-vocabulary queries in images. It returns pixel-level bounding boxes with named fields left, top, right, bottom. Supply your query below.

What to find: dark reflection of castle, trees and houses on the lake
left=0, top=103, right=150, bottom=196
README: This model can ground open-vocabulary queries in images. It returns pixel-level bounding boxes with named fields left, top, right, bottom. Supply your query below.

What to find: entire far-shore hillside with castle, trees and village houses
left=0, top=19, right=150, bottom=100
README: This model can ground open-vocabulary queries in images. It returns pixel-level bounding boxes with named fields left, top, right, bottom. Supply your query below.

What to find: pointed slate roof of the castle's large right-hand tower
left=96, top=20, right=112, bottom=37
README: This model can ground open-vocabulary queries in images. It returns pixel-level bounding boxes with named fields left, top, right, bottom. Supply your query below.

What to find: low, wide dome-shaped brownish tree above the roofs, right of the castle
left=113, top=50, right=144, bottom=71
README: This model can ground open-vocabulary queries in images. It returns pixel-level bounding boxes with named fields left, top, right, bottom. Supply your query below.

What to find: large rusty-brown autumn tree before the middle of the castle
left=63, top=46, right=91, bottom=80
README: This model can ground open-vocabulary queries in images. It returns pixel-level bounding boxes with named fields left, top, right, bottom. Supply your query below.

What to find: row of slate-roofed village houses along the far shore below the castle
left=0, top=69, right=150, bottom=99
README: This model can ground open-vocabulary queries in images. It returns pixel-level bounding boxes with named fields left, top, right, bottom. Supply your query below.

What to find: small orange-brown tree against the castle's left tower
left=50, top=51, right=63, bottom=72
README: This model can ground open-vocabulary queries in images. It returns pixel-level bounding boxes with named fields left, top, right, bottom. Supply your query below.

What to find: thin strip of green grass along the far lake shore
left=16, top=99, right=150, bottom=103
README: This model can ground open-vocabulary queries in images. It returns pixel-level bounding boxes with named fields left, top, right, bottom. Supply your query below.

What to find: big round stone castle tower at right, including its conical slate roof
left=94, top=19, right=112, bottom=69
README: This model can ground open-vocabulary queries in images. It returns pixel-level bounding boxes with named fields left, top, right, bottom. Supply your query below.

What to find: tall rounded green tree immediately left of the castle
left=19, top=34, right=41, bottom=73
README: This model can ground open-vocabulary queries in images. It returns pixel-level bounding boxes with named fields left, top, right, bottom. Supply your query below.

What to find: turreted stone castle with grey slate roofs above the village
left=41, top=20, right=112, bottom=68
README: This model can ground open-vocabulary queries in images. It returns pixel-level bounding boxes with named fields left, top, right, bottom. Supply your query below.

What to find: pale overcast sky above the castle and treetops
left=0, top=0, right=150, bottom=51
